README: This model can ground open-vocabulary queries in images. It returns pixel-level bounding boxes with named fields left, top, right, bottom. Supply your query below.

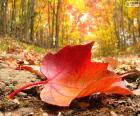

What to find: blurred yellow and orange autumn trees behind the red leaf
left=0, top=0, right=140, bottom=56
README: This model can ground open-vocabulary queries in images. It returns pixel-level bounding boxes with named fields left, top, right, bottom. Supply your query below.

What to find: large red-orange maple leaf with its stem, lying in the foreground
left=9, top=42, right=132, bottom=106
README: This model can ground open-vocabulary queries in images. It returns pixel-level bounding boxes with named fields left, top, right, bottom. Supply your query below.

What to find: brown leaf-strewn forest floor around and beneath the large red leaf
left=0, top=37, right=140, bottom=116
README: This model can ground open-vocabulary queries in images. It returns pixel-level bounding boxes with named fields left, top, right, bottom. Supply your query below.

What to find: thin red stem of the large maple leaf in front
left=8, top=80, right=48, bottom=99
